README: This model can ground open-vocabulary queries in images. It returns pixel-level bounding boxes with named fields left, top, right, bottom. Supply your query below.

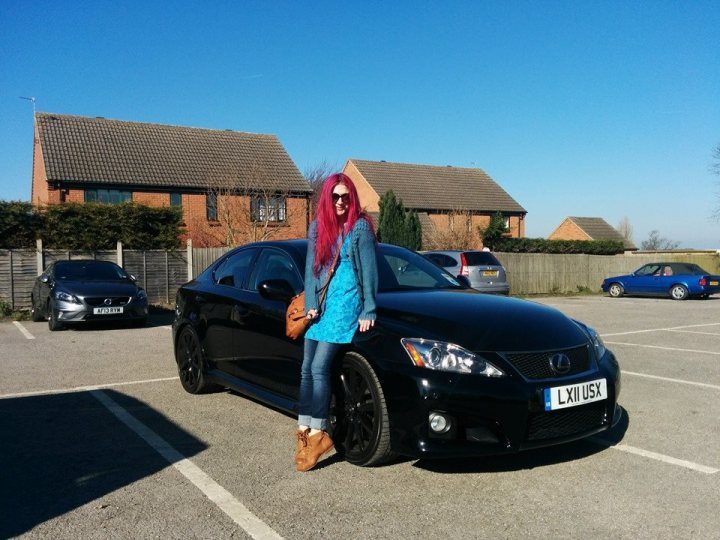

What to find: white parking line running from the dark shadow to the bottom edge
left=90, top=390, right=282, bottom=540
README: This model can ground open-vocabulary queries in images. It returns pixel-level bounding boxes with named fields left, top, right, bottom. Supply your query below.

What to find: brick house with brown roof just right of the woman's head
left=343, top=159, right=527, bottom=249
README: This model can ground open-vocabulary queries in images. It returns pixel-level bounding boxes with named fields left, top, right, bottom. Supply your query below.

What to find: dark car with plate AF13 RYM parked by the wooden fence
left=30, top=259, right=148, bottom=331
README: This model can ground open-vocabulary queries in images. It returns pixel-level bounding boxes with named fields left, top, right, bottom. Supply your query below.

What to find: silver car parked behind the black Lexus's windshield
left=422, top=250, right=510, bottom=295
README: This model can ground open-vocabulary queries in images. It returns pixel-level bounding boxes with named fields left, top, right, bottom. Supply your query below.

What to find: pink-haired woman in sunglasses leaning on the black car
left=295, top=173, right=377, bottom=471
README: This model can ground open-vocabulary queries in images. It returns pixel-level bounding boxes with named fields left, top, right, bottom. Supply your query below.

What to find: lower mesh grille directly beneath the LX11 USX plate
left=527, top=401, right=606, bottom=441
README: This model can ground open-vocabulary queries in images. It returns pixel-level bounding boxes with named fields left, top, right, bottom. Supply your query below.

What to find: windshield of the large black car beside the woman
left=377, top=245, right=465, bottom=291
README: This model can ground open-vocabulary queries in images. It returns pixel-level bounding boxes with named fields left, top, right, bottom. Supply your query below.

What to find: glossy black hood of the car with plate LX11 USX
left=377, top=289, right=588, bottom=352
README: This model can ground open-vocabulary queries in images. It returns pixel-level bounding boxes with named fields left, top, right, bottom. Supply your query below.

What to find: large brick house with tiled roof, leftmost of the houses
left=32, top=113, right=312, bottom=246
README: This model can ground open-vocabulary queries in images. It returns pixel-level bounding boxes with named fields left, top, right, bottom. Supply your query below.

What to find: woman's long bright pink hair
left=313, top=173, right=375, bottom=275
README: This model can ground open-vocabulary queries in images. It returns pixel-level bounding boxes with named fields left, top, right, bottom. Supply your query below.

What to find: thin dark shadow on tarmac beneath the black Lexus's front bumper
left=413, top=409, right=630, bottom=474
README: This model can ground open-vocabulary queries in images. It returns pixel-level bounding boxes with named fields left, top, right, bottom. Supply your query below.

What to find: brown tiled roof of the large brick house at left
left=35, top=113, right=311, bottom=193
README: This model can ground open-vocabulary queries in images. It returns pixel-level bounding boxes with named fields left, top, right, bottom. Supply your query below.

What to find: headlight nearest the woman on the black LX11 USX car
left=400, top=338, right=505, bottom=377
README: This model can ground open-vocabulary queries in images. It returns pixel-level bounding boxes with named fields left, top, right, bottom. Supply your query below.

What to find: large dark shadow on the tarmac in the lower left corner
left=0, top=390, right=207, bottom=538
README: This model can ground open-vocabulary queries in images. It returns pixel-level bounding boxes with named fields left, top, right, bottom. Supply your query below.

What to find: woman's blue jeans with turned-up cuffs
left=298, top=338, right=341, bottom=431
